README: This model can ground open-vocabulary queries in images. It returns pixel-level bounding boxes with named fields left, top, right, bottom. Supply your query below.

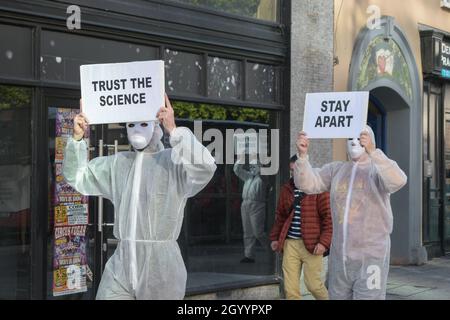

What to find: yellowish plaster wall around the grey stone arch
left=333, top=0, right=450, bottom=160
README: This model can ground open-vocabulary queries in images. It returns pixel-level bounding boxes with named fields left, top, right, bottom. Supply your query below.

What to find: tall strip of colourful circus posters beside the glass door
left=53, top=108, right=90, bottom=296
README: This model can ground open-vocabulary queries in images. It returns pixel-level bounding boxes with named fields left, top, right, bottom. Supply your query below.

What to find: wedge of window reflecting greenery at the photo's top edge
left=172, top=0, right=279, bottom=22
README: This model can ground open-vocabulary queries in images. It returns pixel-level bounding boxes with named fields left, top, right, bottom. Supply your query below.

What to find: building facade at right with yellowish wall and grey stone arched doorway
left=333, top=0, right=450, bottom=264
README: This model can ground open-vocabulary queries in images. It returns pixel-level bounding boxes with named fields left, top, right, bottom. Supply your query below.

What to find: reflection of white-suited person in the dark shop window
left=234, top=161, right=270, bottom=263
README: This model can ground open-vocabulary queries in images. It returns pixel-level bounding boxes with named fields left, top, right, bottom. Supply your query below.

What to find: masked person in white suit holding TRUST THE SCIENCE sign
left=63, top=96, right=216, bottom=300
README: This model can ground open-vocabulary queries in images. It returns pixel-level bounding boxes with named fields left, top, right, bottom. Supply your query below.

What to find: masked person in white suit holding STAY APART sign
left=294, top=126, right=407, bottom=300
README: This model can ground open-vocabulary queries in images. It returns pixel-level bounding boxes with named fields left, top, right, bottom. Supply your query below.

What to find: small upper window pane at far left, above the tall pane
left=0, top=25, right=33, bottom=78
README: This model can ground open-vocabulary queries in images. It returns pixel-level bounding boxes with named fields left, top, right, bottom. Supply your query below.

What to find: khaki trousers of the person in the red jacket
left=283, top=239, right=328, bottom=300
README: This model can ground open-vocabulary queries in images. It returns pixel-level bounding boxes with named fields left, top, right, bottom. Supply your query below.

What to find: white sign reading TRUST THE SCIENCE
left=80, top=60, right=165, bottom=124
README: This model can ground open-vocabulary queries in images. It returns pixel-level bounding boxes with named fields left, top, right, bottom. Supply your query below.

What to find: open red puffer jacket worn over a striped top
left=270, top=179, right=333, bottom=254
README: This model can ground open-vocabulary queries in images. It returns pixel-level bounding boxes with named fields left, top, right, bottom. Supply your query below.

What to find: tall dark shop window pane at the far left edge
left=0, top=86, right=31, bottom=299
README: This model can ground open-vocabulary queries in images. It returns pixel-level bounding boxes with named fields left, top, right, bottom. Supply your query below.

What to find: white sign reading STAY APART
left=303, top=92, right=369, bottom=139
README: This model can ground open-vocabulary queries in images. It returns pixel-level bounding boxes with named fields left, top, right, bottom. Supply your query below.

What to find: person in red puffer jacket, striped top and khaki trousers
left=270, top=156, right=333, bottom=300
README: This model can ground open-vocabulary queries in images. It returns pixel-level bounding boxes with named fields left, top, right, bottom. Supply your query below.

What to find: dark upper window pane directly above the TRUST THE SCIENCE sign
left=40, top=31, right=159, bottom=84
